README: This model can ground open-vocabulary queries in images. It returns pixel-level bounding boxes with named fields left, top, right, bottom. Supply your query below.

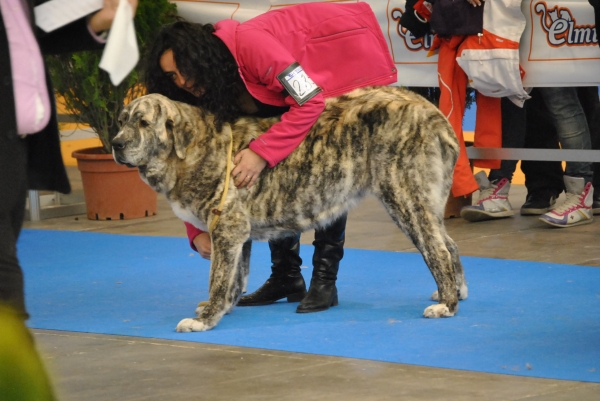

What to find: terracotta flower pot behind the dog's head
left=72, top=147, right=157, bottom=220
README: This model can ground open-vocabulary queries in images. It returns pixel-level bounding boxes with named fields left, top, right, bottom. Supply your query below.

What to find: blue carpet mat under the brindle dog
left=19, top=230, right=600, bottom=382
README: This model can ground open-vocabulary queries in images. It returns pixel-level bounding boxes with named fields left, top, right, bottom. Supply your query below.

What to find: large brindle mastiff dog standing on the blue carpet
left=112, top=87, right=467, bottom=332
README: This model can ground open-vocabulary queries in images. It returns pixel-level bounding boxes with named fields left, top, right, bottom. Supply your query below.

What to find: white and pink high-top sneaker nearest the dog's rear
left=460, top=171, right=515, bottom=222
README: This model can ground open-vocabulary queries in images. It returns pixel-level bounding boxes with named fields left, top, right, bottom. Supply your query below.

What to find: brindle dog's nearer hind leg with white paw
left=376, top=186, right=462, bottom=318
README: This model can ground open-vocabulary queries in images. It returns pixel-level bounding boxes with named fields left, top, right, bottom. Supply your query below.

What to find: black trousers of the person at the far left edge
left=0, top=132, right=29, bottom=319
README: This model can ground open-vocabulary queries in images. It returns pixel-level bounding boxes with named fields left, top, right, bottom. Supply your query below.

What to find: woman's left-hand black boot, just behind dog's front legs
left=237, top=234, right=306, bottom=306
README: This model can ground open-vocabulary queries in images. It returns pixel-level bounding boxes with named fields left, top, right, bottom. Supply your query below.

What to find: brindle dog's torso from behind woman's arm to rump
left=238, top=87, right=459, bottom=230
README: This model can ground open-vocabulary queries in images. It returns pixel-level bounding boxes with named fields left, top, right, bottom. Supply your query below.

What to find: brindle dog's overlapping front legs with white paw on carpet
left=177, top=219, right=250, bottom=332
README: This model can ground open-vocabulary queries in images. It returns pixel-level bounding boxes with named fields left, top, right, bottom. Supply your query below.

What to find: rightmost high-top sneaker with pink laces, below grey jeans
left=540, top=175, right=594, bottom=227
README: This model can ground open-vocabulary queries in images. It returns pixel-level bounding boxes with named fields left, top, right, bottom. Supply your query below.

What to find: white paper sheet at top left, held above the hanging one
left=33, top=0, right=104, bottom=32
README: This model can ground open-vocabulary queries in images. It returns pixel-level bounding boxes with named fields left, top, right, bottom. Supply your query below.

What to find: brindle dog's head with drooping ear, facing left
left=111, top=94, right=194, bottom=167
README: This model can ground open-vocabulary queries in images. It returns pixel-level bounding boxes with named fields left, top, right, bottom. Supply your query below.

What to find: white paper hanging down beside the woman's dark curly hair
left=99, top=0, right=140, bottom=86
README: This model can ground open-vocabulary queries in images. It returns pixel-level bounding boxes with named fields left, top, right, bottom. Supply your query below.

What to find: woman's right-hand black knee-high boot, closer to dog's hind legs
left=296, top=215, right=347, bottom=313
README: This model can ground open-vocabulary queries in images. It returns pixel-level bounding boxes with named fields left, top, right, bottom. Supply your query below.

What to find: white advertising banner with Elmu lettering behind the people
left=174, top=0, right=600, bottom=87
